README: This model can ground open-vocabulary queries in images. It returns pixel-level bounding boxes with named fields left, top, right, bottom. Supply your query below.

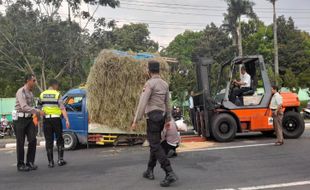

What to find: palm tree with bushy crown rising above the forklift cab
left=224, top=0, right=257, bottom=56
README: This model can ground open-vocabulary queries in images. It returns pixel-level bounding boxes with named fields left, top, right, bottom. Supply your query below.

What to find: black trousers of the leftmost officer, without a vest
left=15, top=117, right=37, bottom=166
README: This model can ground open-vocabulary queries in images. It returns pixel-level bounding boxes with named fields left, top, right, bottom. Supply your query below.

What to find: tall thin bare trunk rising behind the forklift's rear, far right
left=267, top=0, right=279, bottom=85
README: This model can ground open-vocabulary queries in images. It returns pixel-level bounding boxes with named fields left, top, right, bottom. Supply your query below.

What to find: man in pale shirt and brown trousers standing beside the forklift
left=270, top=86, right=284, bottom=145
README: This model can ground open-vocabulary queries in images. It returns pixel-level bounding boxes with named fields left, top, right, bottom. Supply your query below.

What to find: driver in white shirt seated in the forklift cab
left=230, top=66, right=251, bottom=103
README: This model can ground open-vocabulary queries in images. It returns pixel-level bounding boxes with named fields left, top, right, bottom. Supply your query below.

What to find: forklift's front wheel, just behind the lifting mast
left=211, top=113, right=237, bottom=142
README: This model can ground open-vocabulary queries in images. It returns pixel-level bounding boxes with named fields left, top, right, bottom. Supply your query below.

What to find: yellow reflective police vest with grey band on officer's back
left=40, top=90, right=61, bottom=116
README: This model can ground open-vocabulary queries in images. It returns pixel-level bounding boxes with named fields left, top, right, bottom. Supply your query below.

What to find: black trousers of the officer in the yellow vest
left=43, top=118, right=64, bottom=151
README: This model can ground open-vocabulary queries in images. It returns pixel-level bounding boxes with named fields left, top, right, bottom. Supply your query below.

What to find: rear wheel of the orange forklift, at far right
left=282, top=111, right=305, bottom=139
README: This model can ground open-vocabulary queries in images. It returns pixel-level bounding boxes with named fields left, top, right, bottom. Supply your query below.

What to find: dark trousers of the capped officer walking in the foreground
left=147, top=112, right=172, bottom=172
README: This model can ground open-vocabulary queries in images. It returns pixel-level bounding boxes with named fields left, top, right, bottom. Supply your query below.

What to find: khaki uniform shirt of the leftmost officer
left=15, top=85, right=37, bottom=114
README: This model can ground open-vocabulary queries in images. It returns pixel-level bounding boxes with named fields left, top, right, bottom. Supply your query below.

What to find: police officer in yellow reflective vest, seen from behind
left=40, top=79, right=70, bottom=168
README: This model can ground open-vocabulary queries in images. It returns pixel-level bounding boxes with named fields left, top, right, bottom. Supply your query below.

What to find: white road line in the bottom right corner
left=217, top=181, right=310, bottom=190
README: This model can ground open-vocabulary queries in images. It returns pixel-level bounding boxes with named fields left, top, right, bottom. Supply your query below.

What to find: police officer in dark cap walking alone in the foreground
left=131, top=61, right=177, bottom=187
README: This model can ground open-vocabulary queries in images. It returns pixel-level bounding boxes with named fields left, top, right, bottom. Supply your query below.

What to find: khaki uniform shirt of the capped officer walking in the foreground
left=134, top=75, right=171, bottom=122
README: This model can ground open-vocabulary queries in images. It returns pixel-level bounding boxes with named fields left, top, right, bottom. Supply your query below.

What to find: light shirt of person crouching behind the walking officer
left=161, top=120, right=180, bottom=146
